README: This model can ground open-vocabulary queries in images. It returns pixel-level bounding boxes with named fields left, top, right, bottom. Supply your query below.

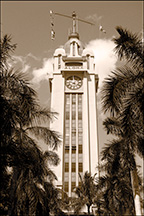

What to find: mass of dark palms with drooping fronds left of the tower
left=0, top=36, right=62, bottom=215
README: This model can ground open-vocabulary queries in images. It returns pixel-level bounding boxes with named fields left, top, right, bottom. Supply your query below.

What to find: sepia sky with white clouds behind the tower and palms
left=1, top=1, right=143, bottom=167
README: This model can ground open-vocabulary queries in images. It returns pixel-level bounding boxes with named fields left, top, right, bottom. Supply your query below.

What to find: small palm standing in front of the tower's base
left=72, top=171, right=96, bottom=215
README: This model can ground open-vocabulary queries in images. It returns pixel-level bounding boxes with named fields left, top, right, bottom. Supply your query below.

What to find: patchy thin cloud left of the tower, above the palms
left=8, top=53, right=53, bottom=106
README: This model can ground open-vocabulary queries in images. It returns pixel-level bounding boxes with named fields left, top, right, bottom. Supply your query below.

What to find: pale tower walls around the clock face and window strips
left=48, top=39, right=98, bottom=196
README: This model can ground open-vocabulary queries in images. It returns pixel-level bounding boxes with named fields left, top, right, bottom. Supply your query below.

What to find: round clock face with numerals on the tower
left=66, top=76, right=82, bottom=90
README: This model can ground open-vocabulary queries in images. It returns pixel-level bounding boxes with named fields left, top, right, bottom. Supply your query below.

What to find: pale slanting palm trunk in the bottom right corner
left=131, top=169, right=142, bottom=216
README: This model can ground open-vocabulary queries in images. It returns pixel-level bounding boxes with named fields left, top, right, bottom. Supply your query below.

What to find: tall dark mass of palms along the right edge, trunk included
left=100, top=27, right=144, bottom=215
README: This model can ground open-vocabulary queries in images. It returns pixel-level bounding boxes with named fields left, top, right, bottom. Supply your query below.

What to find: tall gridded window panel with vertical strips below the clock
left=63, top=92, right=83, bottom=179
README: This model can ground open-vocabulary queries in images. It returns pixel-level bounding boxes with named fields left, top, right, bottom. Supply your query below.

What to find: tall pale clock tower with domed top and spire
left=49, top=13, right=99, bottom=197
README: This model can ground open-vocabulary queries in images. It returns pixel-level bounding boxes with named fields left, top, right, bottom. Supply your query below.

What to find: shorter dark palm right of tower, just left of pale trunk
left=97, top=139, right=135, bottom=216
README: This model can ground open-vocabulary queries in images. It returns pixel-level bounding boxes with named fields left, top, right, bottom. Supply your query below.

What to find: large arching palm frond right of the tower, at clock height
left=101, top=66, right=144, bottom=113
